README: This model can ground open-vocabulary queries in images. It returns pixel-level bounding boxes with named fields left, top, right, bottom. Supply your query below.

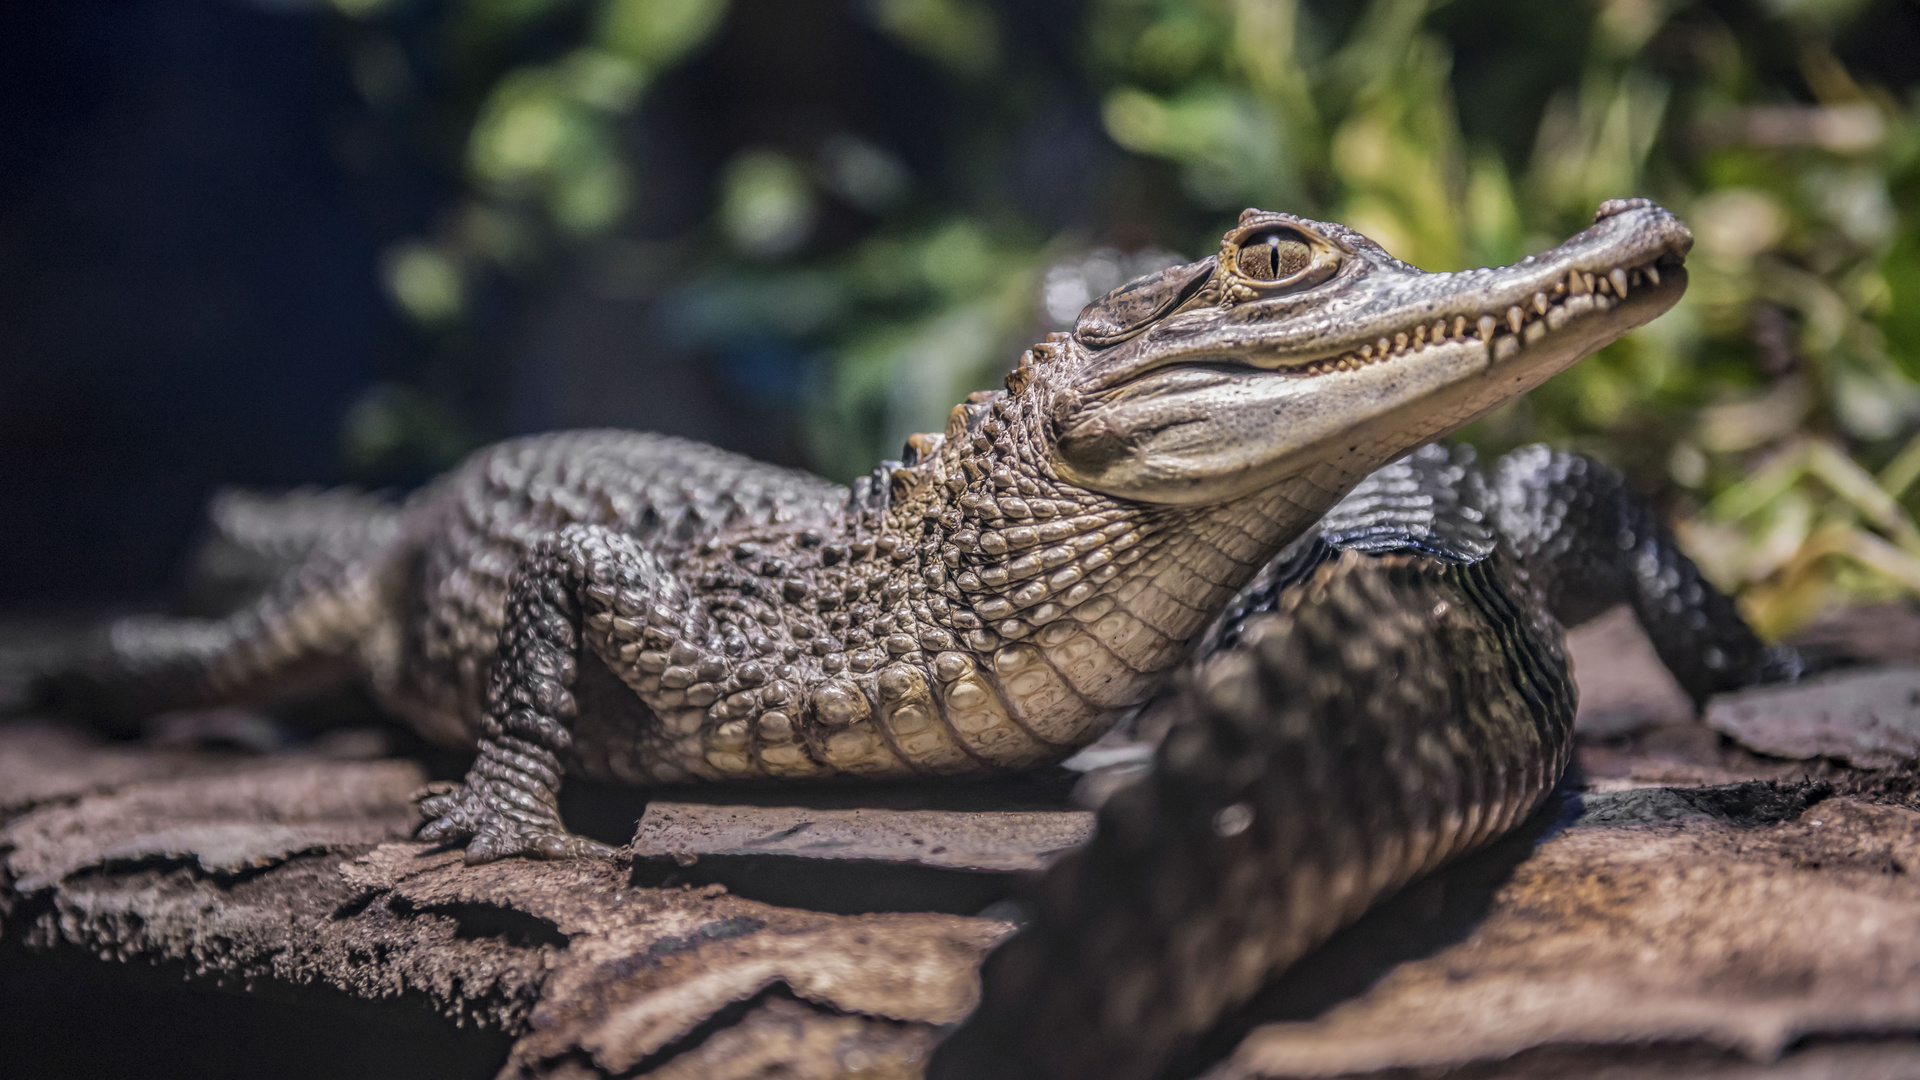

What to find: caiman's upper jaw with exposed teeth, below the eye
left=1089, top=200, right=1693, bottom=388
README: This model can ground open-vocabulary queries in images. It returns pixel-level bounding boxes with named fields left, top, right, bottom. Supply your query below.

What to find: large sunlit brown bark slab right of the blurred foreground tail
left=1212, top=784, right=1920, bottom=1080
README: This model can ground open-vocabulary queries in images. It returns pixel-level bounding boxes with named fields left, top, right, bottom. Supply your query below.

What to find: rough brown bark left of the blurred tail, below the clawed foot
left=0, top=722, right=1008, bottom=1076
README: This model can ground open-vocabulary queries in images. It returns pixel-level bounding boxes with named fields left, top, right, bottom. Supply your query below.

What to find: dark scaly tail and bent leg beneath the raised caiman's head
left=929, top=446, right=1795, bottom=1080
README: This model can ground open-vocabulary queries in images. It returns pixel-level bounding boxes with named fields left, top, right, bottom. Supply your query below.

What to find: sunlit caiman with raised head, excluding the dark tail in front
left=41, top=200, right=1692, bottom=861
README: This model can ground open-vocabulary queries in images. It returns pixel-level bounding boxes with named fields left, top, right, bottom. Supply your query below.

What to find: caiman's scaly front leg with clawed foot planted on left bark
left=420, top=525, right=695, bottom=863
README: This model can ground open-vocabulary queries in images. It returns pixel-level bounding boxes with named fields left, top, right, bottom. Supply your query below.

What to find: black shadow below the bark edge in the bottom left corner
left=0, top=949, right=513, bottom=1080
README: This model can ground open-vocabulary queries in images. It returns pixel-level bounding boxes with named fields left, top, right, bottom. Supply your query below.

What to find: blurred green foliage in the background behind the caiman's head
left=334, top=0, right=1920, bottom=634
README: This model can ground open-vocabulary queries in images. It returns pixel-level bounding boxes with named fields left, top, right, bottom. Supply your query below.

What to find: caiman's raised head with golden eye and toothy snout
left=1036, top=198, right=1693, bottom=505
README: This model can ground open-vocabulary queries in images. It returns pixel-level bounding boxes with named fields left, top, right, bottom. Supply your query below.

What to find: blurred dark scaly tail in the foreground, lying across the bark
left=927, top=552, right=1574, bottom=1080
